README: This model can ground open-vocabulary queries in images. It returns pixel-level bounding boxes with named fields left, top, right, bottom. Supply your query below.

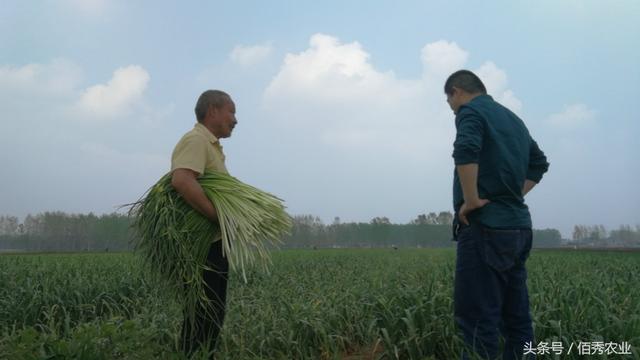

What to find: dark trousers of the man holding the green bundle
left=182, top=241, right=229, bottom=355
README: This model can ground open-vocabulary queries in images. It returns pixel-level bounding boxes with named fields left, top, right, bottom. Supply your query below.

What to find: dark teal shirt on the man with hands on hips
left=453, top=95, right=549, bottom=229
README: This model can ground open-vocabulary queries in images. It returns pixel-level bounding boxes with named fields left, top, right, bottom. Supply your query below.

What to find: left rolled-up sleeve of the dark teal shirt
left=453, top=109, right=484, bottom=165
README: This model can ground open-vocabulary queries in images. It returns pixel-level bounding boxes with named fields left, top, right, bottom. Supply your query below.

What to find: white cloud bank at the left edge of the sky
left=0, top=58, right=158, bottom=126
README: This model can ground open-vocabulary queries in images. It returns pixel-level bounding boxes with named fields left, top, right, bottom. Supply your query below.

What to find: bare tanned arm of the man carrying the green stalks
left=171, top=168, right=218, bottom=222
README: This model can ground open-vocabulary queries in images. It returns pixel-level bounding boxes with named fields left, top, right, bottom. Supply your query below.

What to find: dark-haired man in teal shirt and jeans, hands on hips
left=444, top=70, right=549, bottom=359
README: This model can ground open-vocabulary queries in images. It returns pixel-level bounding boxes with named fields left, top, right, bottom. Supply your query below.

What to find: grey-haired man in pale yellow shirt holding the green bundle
left=171, top=90, right=238, bottom=354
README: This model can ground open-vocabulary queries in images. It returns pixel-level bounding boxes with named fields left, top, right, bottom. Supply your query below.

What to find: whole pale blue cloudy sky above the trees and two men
left=0, top=0, right=640, bottom=236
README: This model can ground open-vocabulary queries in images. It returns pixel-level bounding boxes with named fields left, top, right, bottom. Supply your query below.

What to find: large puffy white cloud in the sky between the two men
left=264, top=34, right=423, bottom=152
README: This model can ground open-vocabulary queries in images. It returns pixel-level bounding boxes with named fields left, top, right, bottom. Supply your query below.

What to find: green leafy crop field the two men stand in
left=0, top=249, right=640, bottom=359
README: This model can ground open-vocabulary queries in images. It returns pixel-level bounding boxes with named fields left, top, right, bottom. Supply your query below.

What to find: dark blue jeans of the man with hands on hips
left=454, top=225, right=535, bottom=359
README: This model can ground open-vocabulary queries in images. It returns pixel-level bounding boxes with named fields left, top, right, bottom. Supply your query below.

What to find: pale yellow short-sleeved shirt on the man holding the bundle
left=171, top=123, right=228, bottom=175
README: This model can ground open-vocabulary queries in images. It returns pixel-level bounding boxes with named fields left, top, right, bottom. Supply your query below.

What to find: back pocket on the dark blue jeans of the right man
left=482, top=228, right=521, bottom=271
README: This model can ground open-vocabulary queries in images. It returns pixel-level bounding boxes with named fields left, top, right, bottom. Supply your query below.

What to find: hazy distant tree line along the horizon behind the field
left=0, top=211, right=640, bottom=252
